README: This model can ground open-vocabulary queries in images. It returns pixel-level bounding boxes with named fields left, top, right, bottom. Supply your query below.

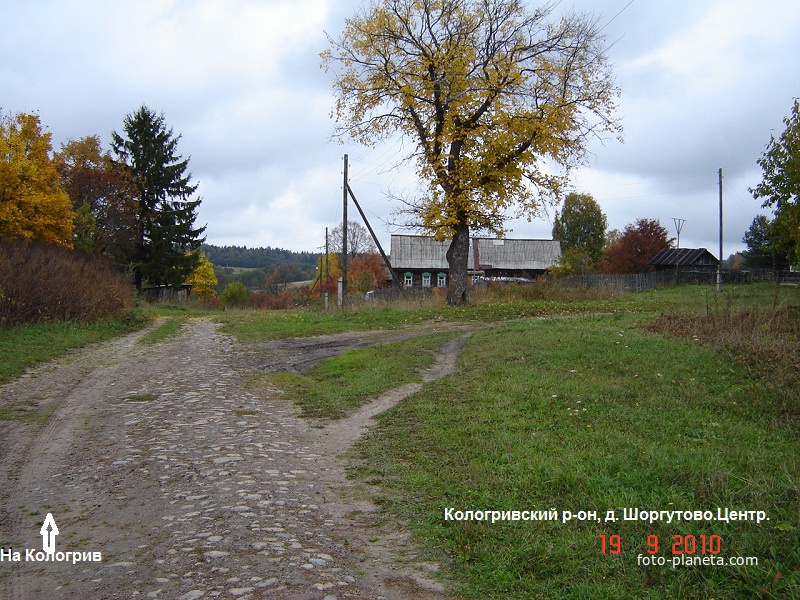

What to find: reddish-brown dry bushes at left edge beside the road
left=0, top=240, right=134, bottom=327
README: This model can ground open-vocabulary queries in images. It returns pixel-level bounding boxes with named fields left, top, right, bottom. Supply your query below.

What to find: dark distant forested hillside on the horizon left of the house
left=201, top=244, right=321, bottom=288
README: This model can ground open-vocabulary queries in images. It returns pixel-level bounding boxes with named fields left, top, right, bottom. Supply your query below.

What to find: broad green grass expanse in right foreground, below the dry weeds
left=358, top=315, right=800, bottom=598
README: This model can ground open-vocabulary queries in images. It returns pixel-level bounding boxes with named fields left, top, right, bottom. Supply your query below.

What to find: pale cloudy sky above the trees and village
left=0, top=0, right=800, bottom=256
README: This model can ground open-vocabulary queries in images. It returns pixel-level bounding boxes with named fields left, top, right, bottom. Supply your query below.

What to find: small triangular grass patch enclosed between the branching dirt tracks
left=261, top=333, right=457, bottom=419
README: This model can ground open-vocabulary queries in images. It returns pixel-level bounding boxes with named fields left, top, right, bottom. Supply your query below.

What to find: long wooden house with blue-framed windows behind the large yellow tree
left=390, top=235, right=561, bottom=288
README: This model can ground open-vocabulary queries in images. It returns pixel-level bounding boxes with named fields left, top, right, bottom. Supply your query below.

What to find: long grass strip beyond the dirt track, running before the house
left=216, top=283, right=799, bottom=342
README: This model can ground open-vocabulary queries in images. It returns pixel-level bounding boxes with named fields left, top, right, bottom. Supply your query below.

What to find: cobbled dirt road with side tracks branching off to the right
left=0, top=320, right=463, bottom=600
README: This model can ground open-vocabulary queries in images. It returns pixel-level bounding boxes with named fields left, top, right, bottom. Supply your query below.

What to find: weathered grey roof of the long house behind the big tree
left=391, top=235, right=561, bottom=271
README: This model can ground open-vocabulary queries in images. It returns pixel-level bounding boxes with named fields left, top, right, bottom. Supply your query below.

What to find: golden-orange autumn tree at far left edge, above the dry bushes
left=0, top=113, right=74, bottom=248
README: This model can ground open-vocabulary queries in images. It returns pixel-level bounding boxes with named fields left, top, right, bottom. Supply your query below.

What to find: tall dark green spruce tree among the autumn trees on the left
left=111, top=105, right=205, bottom=290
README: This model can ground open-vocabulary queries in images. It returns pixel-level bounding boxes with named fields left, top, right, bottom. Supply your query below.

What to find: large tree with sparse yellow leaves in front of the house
left=323, top=0, right=619, bottom=304
